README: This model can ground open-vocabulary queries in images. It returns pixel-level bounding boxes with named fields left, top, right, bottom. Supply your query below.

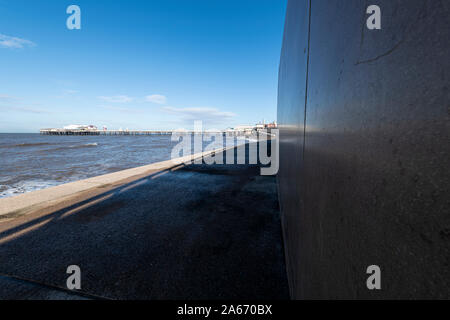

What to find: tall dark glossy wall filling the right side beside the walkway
left=278, top=0, right=450, bottom=298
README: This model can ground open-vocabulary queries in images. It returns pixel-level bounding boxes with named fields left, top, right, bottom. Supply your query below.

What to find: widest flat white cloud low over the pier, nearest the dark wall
left=162, top=106, right=236, bottom=123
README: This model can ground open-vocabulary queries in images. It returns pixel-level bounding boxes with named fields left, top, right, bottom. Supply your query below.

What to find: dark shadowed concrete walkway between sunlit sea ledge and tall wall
left=0, top=148, right=288, bottom=299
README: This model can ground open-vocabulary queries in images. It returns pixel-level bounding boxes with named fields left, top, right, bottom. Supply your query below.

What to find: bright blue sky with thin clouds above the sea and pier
left=0, top=0, right=287, bottom=132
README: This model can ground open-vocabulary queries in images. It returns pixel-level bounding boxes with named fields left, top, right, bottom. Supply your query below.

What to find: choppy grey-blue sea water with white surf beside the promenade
left=0, top=133, right=241, bottom=198
